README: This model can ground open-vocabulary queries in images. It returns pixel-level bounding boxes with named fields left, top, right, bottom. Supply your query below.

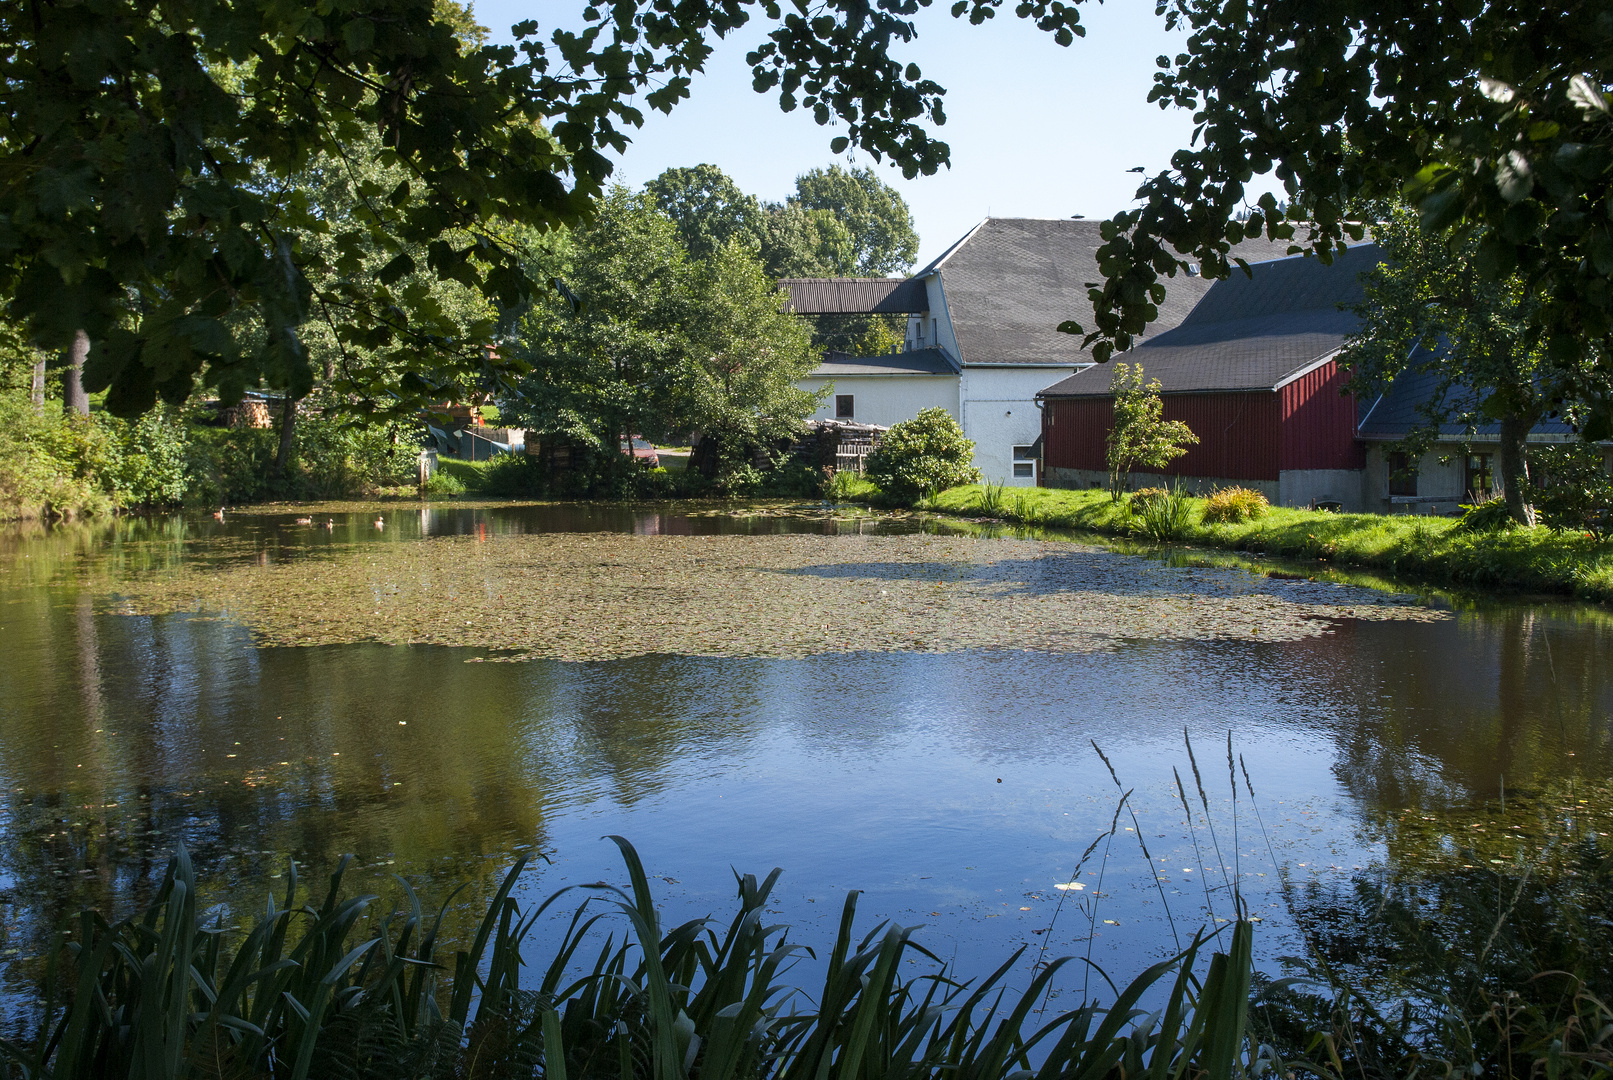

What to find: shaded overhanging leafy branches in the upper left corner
left=0, top=0, right=1081, bottom=414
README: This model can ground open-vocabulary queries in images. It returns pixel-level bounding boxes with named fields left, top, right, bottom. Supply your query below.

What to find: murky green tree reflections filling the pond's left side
left=0, top=593, right=558, bottom=973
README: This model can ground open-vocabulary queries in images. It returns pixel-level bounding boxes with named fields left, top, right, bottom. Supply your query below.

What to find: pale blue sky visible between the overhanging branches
left=476, top=0, right=1245, bottom=264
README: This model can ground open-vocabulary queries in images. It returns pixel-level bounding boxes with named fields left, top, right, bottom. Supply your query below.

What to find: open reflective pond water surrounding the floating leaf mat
left=0, top=506, right=1613, bottom=1005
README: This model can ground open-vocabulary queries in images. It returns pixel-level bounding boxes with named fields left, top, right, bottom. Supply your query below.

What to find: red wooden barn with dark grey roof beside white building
left=1037, top=243, right=1381, bottom=509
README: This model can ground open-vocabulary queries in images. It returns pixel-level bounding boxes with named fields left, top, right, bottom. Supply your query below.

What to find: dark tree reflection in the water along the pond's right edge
left=1334, top=604, right=1613, bottom=806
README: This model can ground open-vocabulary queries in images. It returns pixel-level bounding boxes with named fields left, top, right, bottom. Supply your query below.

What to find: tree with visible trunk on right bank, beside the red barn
left=1347, top=206, right=1595, bottom=525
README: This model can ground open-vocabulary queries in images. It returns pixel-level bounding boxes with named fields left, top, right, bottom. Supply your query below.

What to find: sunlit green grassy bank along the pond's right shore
left=840, top=482, right=1613, bottom=603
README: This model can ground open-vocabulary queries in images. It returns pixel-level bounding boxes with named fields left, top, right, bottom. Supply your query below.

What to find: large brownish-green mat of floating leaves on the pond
left=113, top=534, right=1448, bottom=661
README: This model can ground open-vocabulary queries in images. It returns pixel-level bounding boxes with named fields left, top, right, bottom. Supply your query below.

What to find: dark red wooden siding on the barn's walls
left=1042, top=392, right=1279, bottom=480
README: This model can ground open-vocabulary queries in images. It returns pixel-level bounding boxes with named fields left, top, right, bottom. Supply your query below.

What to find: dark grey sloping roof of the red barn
left=1042, top=243, right=1382, bottom=398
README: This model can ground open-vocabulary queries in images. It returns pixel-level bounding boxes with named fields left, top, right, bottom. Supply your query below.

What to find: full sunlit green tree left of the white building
left=508, top=187, right=818, bottom=484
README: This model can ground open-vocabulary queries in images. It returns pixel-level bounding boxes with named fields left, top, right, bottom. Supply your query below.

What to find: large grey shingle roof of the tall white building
left=919, top=218, right=1287, bottom=366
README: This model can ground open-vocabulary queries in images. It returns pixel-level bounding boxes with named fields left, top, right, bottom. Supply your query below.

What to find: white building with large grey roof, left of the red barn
left=779, top=218, right=1281, bottom=487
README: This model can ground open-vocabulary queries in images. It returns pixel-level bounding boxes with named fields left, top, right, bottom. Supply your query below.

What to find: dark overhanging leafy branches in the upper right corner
left=1063, top=0, right=1613, bottom=438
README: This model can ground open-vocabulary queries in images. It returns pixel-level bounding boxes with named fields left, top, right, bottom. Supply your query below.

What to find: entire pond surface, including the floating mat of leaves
left=0, top=505, right=1613, bottom=1012
